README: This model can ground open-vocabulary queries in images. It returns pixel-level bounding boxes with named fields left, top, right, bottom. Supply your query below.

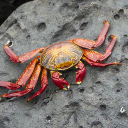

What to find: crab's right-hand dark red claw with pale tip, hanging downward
left=76, top=61, right=86, bottom=84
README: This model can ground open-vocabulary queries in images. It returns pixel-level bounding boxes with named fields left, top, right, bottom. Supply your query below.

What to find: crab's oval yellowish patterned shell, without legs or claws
left=40, top=41, right=83, bottom=70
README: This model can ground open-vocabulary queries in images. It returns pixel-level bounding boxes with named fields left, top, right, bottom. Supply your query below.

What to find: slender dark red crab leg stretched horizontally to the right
left=82, top=56, right=122, bottom=67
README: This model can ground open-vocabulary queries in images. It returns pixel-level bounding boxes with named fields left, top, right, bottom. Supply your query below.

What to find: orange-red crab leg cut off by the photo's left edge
left=0, top=58, right=39, bottom=90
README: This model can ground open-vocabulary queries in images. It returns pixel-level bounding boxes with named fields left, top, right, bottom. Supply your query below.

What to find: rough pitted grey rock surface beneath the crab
left=0, top=0, right=128, bottom=128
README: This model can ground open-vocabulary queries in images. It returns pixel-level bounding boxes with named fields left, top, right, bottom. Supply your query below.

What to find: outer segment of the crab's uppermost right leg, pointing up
left=93, top=21, right=110, bottom=48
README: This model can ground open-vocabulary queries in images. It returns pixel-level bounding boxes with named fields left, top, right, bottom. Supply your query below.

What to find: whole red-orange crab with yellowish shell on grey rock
left=0, top=21, right=121, bottom=101
